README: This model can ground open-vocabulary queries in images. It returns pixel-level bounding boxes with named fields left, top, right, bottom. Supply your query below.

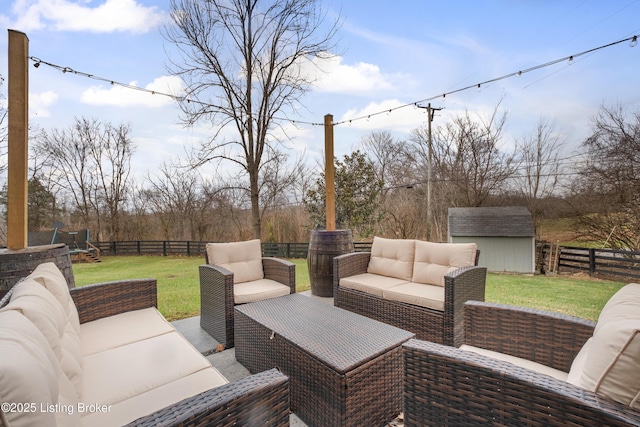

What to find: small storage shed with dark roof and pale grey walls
left=449, top=206, right=536, bottom=273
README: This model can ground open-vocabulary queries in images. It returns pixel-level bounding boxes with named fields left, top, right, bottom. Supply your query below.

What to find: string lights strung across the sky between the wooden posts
left=29, top=35, right=638, bottom=126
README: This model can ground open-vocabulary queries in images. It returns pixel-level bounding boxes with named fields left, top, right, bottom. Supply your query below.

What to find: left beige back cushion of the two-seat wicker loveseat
left=367, top=237, right=416, bottom=280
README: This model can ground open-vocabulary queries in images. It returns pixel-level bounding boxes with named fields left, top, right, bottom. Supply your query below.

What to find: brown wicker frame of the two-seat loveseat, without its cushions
left=333, top=246, right=487, bottom=346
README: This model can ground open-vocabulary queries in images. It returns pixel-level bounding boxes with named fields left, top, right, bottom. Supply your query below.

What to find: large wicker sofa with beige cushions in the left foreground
left=0, top=263, right=289, bottom=427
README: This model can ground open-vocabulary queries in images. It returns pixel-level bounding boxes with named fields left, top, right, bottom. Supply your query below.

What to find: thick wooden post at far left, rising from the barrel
left=7, top=30, right=29, bottom=249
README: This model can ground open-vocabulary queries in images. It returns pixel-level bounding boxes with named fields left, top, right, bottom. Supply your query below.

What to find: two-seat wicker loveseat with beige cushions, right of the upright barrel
left=333, top=237, right=487, bottom=345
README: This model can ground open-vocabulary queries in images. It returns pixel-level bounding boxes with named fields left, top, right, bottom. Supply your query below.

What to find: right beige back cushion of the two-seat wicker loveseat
left=411, top=240, right=477, bottom=286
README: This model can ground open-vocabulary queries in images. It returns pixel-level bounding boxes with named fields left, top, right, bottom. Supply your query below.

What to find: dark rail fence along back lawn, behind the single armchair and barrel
left=92, top=240, right=371, bottom=258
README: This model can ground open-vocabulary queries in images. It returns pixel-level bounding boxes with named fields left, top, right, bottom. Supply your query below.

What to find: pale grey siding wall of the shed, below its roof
left=451, top=236, right=535, bottom=273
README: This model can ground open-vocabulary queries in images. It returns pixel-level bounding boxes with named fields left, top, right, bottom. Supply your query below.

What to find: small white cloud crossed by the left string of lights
left=81, top=76, right=184, bottom=107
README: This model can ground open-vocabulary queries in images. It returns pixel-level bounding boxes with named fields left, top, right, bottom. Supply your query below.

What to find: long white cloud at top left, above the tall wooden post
left=4, top=0, right=164, bottom=33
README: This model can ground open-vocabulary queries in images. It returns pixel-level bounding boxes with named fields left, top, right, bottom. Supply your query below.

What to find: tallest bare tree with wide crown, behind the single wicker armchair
left=164, top=0, right=337, bottom=238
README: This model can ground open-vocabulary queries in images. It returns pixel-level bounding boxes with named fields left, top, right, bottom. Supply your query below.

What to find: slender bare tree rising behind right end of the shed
left=516, top=118, right=564, bottom=235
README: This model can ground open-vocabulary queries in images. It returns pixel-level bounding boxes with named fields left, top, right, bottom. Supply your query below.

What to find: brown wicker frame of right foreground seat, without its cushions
left=403, top=301, right=640, bottom=427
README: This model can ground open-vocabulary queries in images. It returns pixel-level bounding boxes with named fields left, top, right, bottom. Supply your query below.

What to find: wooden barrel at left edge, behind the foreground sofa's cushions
left=0, top=244, right=75, bottom=291
